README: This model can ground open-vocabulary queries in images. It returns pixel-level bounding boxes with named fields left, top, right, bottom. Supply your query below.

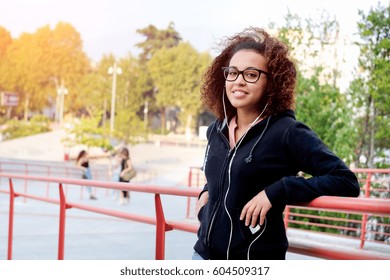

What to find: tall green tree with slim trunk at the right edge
left=350, top=4, right=390, bottom=168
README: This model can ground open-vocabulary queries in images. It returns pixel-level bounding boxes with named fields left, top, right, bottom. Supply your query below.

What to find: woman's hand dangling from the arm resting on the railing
left=240, top=191, right=272, bottom=227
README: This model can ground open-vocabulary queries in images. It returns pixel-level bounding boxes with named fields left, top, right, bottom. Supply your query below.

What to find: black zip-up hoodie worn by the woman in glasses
left=194, top=110, right=359, bottom=259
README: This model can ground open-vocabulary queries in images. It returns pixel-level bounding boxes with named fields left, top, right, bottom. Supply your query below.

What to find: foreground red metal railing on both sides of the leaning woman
left=0, top=173, right=390, bottom=260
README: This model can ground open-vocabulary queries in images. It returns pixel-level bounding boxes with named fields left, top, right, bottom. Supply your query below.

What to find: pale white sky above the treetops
left=0, top=0, right=389, bottom=88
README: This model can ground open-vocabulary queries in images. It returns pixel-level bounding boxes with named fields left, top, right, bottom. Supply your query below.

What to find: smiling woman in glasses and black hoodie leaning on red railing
left=193, top=28, right=359, bottom=259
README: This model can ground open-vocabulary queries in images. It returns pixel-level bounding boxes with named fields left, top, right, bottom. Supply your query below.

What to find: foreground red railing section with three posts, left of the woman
left=0, top=173, right=198, bottom=260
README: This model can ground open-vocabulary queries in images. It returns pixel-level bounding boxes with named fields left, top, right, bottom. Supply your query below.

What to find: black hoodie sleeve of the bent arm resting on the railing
left=265, top=122, right=360, bottom=205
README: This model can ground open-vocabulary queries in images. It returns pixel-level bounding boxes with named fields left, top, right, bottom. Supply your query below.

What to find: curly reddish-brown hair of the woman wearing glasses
left=201, top=27, right=297, bottom=120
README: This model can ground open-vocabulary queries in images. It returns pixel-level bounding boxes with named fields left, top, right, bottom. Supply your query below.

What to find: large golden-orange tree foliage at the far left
left=0, top=22, right=89, bottom=120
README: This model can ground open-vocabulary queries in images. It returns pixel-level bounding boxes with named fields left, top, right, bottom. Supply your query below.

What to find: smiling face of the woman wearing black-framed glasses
left=225, top=49, right=268, bottom=114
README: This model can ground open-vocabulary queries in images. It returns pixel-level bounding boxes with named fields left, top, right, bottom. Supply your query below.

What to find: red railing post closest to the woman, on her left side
left=154, top=193, right=173, bottom=260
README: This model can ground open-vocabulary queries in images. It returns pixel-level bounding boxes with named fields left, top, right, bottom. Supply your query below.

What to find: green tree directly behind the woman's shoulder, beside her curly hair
left=278, top=12, right=355, bottom=163
